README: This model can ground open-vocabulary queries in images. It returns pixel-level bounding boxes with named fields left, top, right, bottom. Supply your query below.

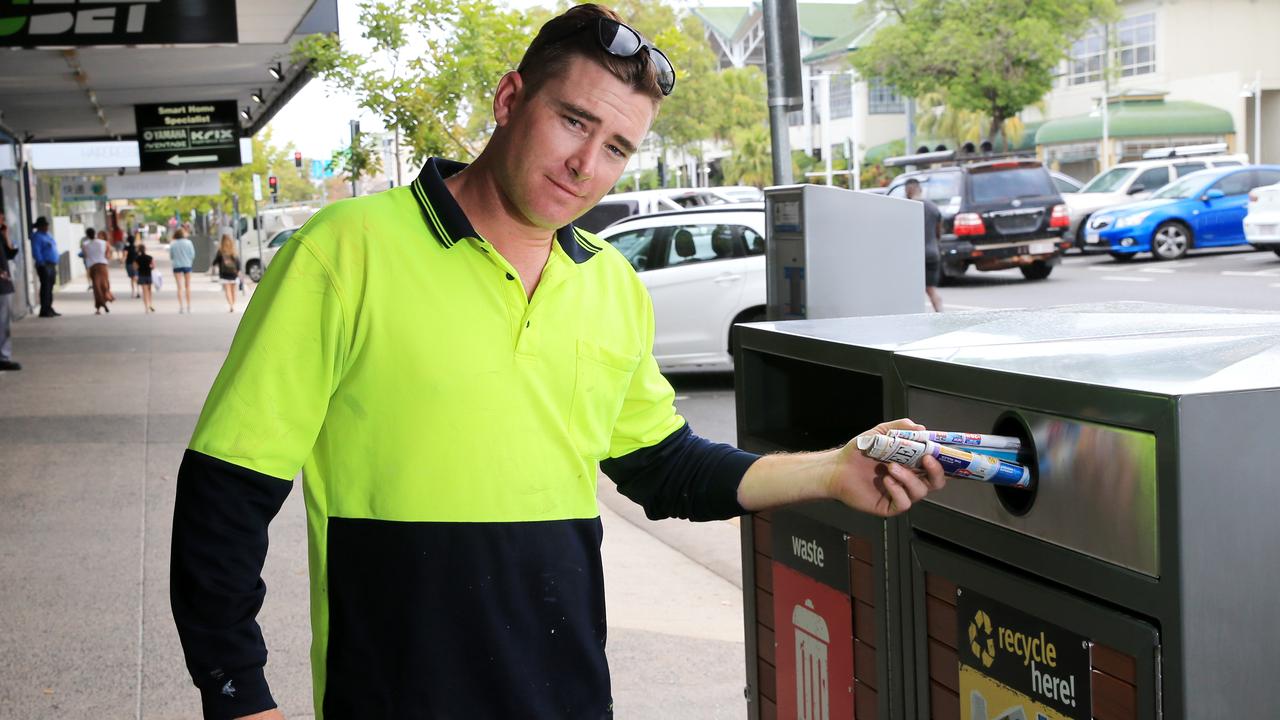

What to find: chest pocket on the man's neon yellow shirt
left=568, top=340, right=640, bottom=460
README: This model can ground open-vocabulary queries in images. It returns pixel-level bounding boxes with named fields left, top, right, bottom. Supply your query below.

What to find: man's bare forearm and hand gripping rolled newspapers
left=737, top=420, right=947, bottom=518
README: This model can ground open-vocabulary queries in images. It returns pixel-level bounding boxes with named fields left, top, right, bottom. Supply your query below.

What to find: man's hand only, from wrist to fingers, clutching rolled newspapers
left=827, top=419, right=947, bottom=518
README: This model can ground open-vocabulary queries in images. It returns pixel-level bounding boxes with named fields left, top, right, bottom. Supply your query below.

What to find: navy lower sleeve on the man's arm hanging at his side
left=169, top=450, right=293, bottom=720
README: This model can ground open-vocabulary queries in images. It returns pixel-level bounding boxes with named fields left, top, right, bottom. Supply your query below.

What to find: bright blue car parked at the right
left=1084, top=165, right=1280, bottom=261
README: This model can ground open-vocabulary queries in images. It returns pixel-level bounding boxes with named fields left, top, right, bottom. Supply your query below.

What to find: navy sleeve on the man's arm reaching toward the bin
left=600, top=423, right=760, bottom=521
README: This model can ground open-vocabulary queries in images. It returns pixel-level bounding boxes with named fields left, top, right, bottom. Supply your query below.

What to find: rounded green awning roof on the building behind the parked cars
left=1036, top=99, right=1235, bottom=145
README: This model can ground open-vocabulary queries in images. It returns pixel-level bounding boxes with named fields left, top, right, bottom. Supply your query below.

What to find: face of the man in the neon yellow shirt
left=494, top=56, right=657, bottom=229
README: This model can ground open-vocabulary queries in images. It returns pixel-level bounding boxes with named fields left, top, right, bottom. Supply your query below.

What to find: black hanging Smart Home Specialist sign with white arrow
left=134, top=100, right=241, bottom=172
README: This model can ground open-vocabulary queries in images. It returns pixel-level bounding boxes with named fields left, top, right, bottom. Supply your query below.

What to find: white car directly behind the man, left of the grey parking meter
left=599, top=202, right=765, bottom=372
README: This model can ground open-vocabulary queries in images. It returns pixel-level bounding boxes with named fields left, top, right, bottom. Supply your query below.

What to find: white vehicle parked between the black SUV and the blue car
left=1062, top=146, right=1249, bottom=247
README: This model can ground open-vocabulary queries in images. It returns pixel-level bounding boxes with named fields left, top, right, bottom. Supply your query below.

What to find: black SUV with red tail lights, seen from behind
left=884, top=151, right=1071, bottom=281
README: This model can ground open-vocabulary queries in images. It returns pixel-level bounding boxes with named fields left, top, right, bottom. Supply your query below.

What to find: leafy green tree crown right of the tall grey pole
left=851, top=0, right=1117, bottom=144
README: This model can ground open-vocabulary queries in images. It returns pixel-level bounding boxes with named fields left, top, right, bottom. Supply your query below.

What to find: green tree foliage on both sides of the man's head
left=297, top=0, right=767, bottom=161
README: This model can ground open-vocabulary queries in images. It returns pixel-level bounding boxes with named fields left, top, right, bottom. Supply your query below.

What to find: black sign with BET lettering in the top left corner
left=0, top=0, right=239, bottom=47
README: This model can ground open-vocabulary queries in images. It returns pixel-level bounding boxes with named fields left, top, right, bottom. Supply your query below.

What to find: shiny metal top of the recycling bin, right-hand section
left=899, top=305, right=1280, bottom=396
